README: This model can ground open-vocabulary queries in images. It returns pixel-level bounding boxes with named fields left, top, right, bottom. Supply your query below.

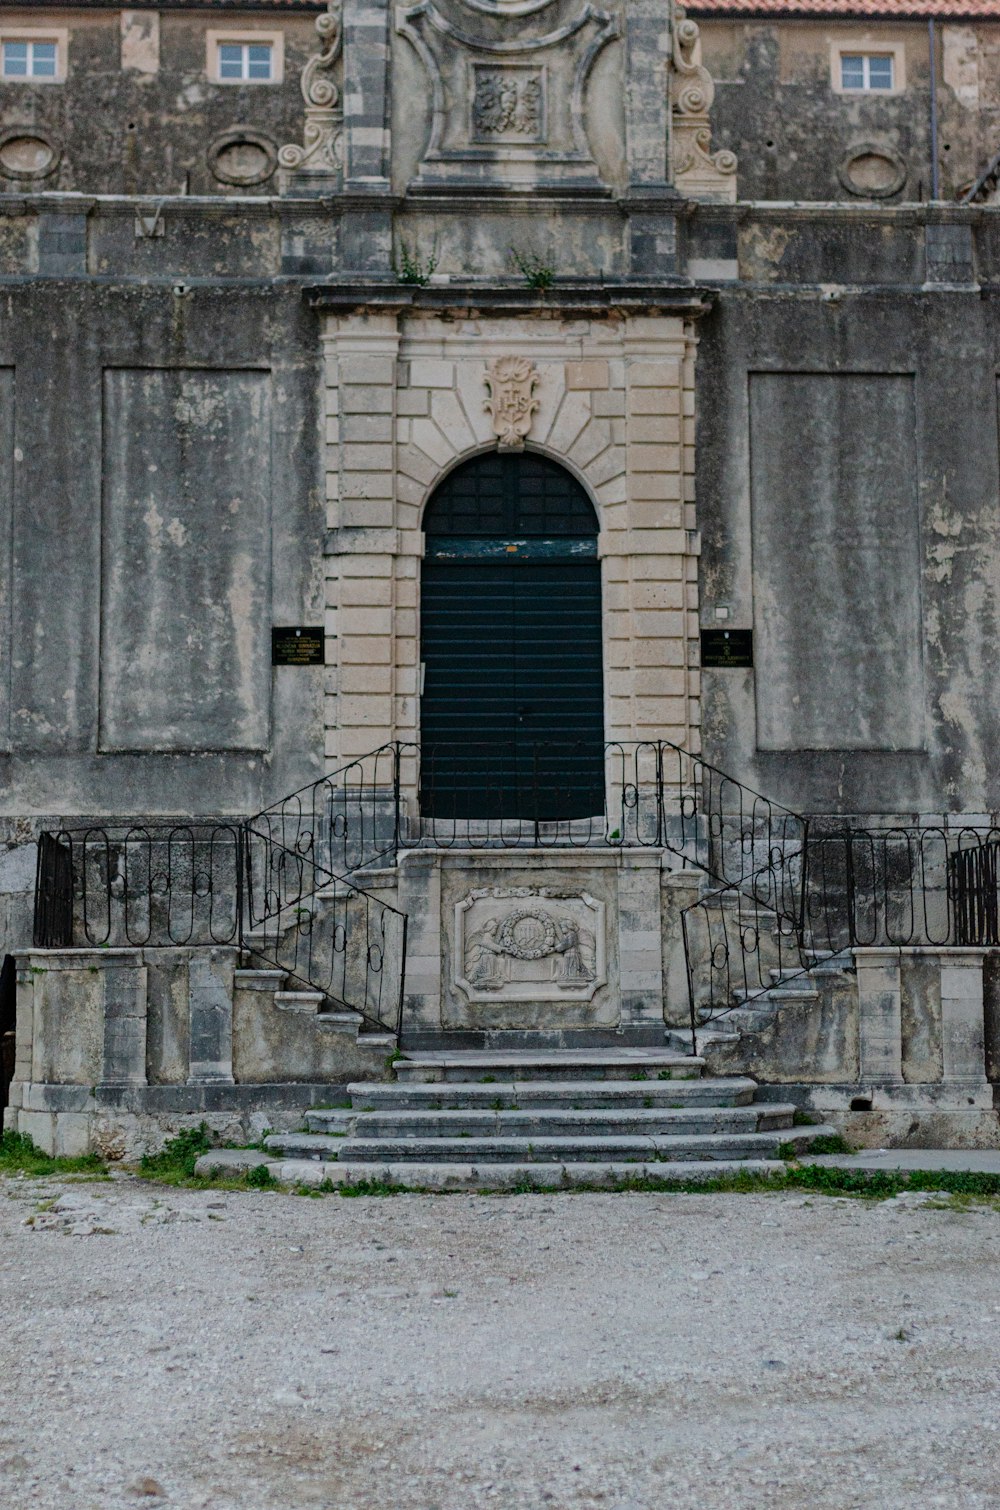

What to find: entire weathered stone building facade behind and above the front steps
left=0, top=0, right=1000, bottom=1151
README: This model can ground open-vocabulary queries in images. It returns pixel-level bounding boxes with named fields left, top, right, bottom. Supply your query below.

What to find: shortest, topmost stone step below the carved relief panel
left=393, top=1048, right=704, bottom=1084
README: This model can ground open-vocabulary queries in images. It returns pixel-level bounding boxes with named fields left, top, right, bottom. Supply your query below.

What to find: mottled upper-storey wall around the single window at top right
left=690, top=6, right=1000, bottom=202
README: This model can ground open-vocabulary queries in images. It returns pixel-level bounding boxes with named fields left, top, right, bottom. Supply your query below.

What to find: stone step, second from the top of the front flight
left=338, top=1075, right=757, bottom=1133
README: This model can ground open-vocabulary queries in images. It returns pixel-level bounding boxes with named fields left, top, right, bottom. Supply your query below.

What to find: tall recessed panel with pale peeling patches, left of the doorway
left=101, top=368, right=270, bottom=750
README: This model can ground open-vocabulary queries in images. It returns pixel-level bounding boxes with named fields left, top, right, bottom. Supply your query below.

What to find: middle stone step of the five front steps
left=297, top=1102, right=795, bottom=1135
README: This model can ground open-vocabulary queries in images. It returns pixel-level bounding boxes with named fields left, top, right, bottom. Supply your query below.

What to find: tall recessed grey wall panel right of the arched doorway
left=749, top=373, right=924, bottom=750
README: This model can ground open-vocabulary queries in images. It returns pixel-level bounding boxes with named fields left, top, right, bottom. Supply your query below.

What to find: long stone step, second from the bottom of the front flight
left=305, top=1126, right=834, bottom=1164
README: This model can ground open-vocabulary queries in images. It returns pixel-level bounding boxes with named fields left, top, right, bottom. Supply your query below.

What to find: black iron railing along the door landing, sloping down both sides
left=248, top=740, right=807, bottom=887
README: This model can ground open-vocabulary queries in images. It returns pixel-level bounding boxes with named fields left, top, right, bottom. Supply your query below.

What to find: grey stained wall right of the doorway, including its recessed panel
left=692, top=207, right=1000, bottom=814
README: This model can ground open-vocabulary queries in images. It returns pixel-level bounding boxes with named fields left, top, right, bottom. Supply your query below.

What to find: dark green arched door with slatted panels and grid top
left=420, top=453, right=604, bottom=821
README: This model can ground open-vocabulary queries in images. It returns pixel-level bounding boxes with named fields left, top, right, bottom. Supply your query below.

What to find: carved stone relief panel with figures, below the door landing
left=453, top=886, right=607, bottom=1003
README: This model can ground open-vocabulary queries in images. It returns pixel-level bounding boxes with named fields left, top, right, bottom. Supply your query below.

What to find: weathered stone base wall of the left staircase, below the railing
left=5, top=948, right=391, bottom=1160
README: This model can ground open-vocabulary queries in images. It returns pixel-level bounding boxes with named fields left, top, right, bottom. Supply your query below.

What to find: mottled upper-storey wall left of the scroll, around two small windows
left=0, top=5, right=322, bottom=195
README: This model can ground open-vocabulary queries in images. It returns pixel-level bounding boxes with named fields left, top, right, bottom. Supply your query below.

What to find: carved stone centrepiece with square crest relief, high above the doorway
left=396, top=0, right=618, bottom=189
